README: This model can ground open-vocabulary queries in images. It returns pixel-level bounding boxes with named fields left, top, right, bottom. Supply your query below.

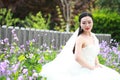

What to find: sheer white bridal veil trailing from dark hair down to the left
left=40, top=28, right=79, bottom=76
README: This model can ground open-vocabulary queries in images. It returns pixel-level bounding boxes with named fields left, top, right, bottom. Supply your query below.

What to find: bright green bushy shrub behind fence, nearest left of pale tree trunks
left=24, top=12, right=50, bottom=30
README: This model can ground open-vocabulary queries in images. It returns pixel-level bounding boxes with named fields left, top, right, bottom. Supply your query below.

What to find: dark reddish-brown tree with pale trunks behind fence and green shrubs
left=0, top=0, right=95, bottom=29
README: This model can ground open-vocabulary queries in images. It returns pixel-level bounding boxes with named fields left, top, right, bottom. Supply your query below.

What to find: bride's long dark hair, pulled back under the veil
left=73, top=12, right=93, bottom=54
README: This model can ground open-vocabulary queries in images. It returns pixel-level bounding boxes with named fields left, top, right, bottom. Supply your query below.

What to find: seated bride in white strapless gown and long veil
left=40, top=12, right=120, bottom=80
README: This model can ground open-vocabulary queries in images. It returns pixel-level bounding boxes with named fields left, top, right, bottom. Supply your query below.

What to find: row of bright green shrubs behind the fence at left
left=0, top=8, right=50, bottom=30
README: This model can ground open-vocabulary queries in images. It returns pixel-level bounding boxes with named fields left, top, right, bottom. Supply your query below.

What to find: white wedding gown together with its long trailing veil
left=40, top=30, right=120, bottom=80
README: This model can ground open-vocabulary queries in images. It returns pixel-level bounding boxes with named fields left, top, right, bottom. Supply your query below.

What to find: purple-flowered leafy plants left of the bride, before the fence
left=0, top=29, right=54, bottom=80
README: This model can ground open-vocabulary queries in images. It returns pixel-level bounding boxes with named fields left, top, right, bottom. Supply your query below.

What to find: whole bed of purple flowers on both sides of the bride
left=0, top=29, right=120, bottom=80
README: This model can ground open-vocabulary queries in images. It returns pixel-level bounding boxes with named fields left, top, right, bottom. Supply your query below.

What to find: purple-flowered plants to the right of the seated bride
left=99, top=39, right=120, bottom=72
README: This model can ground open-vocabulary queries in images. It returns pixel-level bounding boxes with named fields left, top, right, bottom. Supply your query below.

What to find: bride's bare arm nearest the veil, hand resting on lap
left=75, top=36, right=95, bottom=70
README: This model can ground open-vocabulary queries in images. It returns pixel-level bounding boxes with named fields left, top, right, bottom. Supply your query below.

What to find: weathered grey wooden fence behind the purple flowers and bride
left=0, top=26, right=111, bottom=50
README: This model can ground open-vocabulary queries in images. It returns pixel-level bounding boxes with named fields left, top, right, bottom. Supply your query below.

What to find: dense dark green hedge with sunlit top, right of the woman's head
left=92, top=10, right=120, bottom=41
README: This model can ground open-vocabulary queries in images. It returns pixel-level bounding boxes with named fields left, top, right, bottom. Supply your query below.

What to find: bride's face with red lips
left=80, top=16, right=93, bottom=32
